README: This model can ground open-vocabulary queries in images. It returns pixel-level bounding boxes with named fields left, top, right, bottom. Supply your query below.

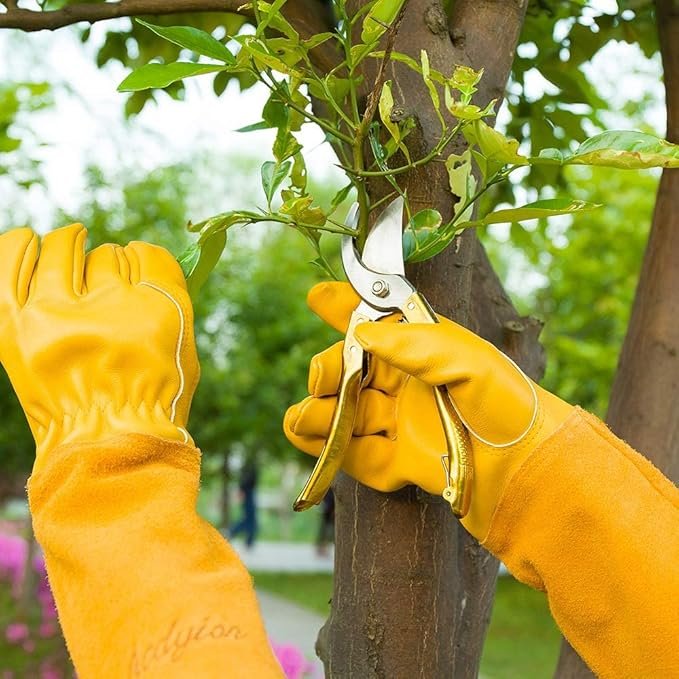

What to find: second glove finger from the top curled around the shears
left=308, top=342, right=406, bottom=397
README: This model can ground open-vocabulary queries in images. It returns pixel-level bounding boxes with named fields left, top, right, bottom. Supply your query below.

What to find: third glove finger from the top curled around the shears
left=283, top=389, right=396, bottom=438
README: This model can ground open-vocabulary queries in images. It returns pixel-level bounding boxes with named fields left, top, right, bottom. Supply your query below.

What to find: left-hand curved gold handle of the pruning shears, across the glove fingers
left=292, top=311, right=370, bottom=512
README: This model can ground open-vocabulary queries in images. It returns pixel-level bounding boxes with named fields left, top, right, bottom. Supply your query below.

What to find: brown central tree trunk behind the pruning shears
left=317, top=0, right=542, bottom=679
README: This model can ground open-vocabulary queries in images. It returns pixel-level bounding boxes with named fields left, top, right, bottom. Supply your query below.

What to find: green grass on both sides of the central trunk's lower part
left=253, top=573, right=559, bottom=679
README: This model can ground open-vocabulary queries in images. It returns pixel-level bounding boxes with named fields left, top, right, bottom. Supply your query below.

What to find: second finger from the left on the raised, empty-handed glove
left=30, top=224, right=87, bottom=298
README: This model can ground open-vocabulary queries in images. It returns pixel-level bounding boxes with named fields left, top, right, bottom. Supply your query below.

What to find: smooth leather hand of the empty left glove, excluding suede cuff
left=0, top=224, right=199, bottom=469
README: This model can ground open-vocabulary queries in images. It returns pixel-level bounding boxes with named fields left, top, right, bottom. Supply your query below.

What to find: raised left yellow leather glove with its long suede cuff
left=0, top=224, right=282, bottom=679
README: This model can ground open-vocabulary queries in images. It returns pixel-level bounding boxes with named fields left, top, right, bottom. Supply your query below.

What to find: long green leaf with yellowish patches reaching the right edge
left=531, top=130, right=679, bottom=170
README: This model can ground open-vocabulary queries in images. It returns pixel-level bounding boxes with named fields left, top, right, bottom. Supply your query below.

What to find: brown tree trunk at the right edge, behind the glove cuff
left=555, top=0, right=679, bottom=679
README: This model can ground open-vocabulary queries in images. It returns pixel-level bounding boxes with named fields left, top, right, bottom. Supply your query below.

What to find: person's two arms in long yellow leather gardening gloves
left=0, top=224, right=679, bottom=679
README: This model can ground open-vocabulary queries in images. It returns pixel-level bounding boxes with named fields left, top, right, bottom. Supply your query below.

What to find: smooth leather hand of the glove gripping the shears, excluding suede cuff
left=284, top=283, right=573, bottom=540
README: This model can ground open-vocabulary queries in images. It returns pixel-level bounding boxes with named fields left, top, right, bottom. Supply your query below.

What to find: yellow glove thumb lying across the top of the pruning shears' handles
left=356, top=319, right=497, bottom=386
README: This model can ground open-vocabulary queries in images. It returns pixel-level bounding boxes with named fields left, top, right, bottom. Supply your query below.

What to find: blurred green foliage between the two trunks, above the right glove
left=483, top=167, right=658, bottom=417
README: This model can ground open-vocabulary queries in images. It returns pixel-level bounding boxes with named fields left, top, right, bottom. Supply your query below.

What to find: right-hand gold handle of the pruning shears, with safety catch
left=402, top=292, right=474, bottom=518
